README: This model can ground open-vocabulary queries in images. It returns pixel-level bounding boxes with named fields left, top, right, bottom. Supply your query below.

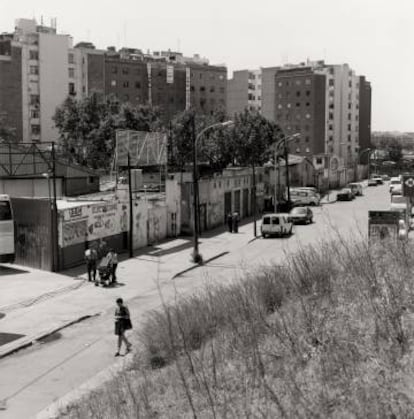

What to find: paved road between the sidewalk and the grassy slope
left=0, top=185, right=389, bottom=419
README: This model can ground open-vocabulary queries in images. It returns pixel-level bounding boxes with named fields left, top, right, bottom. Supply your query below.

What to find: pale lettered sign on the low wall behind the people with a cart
left=60, top=203, right=128, bottom=247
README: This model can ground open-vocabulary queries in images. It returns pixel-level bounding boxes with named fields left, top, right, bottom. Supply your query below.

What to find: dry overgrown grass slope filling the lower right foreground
left=62, top=237, right=414, bottom=419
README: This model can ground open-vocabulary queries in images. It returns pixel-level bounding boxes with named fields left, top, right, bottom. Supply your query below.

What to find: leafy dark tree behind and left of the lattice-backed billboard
left=53, top=95, right=160, bottom=169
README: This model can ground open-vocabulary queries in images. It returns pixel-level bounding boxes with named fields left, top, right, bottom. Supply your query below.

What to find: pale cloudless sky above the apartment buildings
left=0, top=0, right=414, bottom=132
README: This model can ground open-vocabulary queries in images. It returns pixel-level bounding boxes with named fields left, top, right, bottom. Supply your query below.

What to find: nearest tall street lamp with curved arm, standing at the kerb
left=192, top=115, right=234, bottom=265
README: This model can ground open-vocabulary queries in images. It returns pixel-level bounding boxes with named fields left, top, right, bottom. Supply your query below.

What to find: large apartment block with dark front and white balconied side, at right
left=262, top=61, right=371, bottom=164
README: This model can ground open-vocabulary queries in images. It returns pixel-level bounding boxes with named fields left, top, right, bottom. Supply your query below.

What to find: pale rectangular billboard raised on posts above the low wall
left=115, top=130, right=167, bottom=167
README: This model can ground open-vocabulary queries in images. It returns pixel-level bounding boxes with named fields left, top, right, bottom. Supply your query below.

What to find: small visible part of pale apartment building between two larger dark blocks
left=227, top=69, right=262, bottom=116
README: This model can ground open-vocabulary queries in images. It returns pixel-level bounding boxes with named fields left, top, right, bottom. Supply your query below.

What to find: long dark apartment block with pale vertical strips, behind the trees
left=75, top=43, right=227, bottom=118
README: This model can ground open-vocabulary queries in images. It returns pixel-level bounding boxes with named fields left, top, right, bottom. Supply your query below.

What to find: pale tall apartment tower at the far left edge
left=0, top=19, right=83, bottom=142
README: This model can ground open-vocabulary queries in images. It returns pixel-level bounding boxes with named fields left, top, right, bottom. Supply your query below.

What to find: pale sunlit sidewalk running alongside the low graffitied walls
left=0, top=218, right=253, bottom=358
